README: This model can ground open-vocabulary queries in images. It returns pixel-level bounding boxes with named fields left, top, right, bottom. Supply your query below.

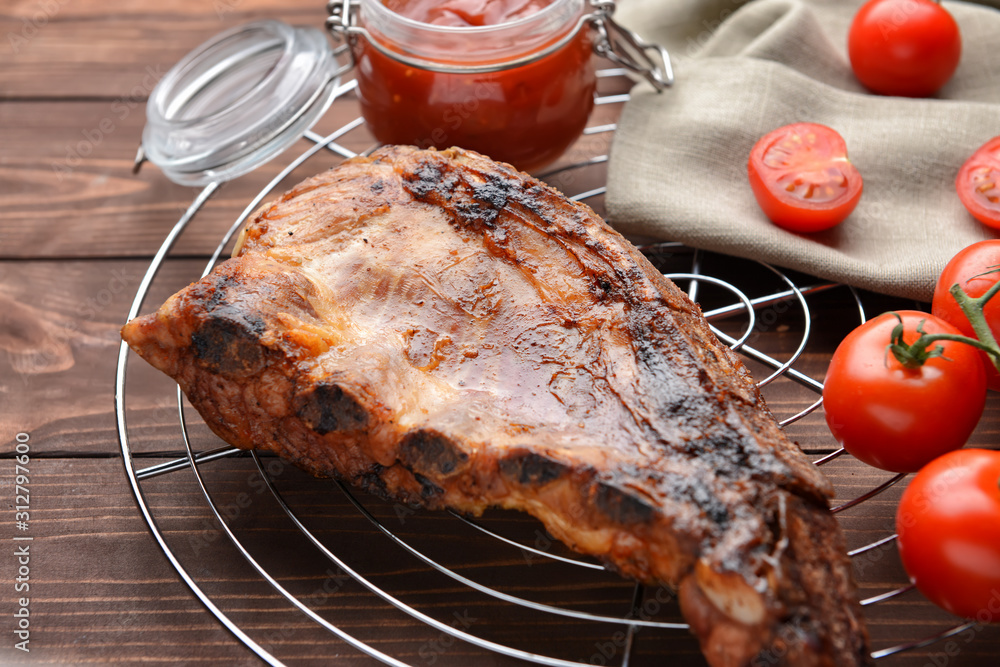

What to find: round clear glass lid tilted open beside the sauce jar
left=141, top=21, right=341, bottom=185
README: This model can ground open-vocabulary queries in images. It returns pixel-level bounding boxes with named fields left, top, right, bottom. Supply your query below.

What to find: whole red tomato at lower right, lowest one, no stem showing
left=896, top=449, right=1000, bottom=623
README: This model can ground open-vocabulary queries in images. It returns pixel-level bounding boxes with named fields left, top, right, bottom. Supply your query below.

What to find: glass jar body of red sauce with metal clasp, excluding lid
left=328, top=0, right=672, bottom=171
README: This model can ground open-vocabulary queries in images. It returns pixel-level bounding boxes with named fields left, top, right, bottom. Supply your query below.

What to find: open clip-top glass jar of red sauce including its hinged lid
left=135, top=0, right=673, bottom=185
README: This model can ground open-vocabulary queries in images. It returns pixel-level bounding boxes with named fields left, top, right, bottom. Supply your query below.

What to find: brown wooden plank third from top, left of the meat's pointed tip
left=0, top=254, right=835, bottom=454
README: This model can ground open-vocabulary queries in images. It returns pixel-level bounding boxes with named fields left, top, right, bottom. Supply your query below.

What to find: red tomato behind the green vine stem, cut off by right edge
left=931, top=240, right=1000, bottom=391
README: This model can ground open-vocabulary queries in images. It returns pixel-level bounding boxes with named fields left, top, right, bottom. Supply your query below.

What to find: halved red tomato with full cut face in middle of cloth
left=747, top=123, right=863, bottom=232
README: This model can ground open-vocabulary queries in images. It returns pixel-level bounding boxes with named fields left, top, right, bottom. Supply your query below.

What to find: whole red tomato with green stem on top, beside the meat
left=823, top=310, right=986, bottom=472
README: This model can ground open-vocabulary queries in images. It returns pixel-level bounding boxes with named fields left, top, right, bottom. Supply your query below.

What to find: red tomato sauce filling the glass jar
left=355, top=0, right=596, bottom=171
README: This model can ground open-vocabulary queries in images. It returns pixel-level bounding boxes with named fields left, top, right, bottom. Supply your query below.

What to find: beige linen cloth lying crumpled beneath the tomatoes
left=606, top=0, right=1000, bottom=301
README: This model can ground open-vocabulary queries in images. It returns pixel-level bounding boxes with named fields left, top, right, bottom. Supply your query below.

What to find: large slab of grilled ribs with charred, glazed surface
left=122, top=147, right=869, bottom=667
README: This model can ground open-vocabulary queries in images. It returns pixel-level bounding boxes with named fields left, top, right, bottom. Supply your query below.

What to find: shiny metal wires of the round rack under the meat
left=115, top=70, right=972, bottom=667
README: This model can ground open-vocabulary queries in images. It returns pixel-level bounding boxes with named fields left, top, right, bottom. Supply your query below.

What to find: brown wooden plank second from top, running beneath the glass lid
left=0, top=90, right=621, bottom=258
